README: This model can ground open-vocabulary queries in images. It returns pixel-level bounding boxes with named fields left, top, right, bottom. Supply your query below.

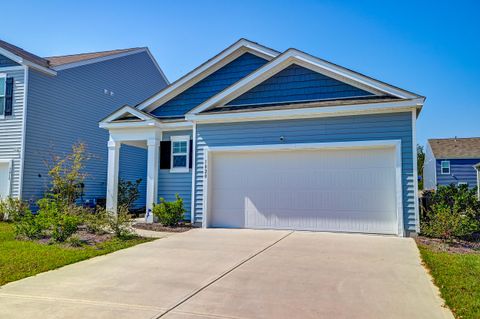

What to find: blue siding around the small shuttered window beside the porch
left=158, top=131, right=192, bottom=220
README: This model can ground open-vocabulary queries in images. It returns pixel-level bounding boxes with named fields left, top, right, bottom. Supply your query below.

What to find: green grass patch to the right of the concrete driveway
left=419, top=245, right=480, bottom=319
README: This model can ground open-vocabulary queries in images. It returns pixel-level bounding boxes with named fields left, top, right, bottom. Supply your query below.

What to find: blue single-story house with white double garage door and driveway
left=100, top=39, right=425, bottom=236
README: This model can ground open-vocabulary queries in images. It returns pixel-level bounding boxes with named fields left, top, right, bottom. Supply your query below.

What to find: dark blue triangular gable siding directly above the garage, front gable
left=228, top=64, right=373, bottom=105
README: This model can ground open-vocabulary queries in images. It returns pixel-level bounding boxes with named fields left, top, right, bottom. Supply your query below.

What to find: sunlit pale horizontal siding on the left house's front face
left=0, top=66, right=25, bottom=197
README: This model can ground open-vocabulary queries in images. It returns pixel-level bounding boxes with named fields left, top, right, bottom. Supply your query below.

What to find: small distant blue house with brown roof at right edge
left=423, top=137, right=480, bottom=195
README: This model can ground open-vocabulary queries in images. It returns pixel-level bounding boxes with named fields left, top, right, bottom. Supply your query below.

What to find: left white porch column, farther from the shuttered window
left=107, top=139, right=121, bottom=214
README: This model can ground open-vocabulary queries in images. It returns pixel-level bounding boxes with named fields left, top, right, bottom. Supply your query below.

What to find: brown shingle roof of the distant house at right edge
left=428, top=137, right=480, bottom=159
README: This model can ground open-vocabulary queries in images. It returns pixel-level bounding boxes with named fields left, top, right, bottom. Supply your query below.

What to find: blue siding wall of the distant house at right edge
left=436, top=158, right=480, bottom=188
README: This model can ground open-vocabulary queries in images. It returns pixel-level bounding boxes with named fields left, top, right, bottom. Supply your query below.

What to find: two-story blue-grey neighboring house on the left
left=0, top=41, right=168, bottom=208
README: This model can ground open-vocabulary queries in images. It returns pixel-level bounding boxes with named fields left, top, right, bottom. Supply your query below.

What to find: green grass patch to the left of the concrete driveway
left=0, top=222, right=151, bottom=286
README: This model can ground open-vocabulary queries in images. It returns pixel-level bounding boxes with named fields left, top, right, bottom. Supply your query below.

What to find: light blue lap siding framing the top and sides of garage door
left=195, top=113, right=415, bottom=231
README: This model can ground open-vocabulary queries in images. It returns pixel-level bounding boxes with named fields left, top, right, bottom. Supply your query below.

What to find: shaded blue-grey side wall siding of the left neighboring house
left=22, top=52, right=166, bottom=206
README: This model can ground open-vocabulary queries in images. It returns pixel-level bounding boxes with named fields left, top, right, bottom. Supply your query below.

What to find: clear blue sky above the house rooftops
left=0, top=0, right=480, bottom=144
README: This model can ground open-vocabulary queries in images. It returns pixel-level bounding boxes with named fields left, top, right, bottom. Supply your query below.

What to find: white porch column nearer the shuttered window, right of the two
left=145, top=138, right=160, bottom=223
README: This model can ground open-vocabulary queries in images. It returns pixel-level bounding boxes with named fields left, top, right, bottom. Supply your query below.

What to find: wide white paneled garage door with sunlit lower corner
left=208, top=147, right=398, bottom=234
